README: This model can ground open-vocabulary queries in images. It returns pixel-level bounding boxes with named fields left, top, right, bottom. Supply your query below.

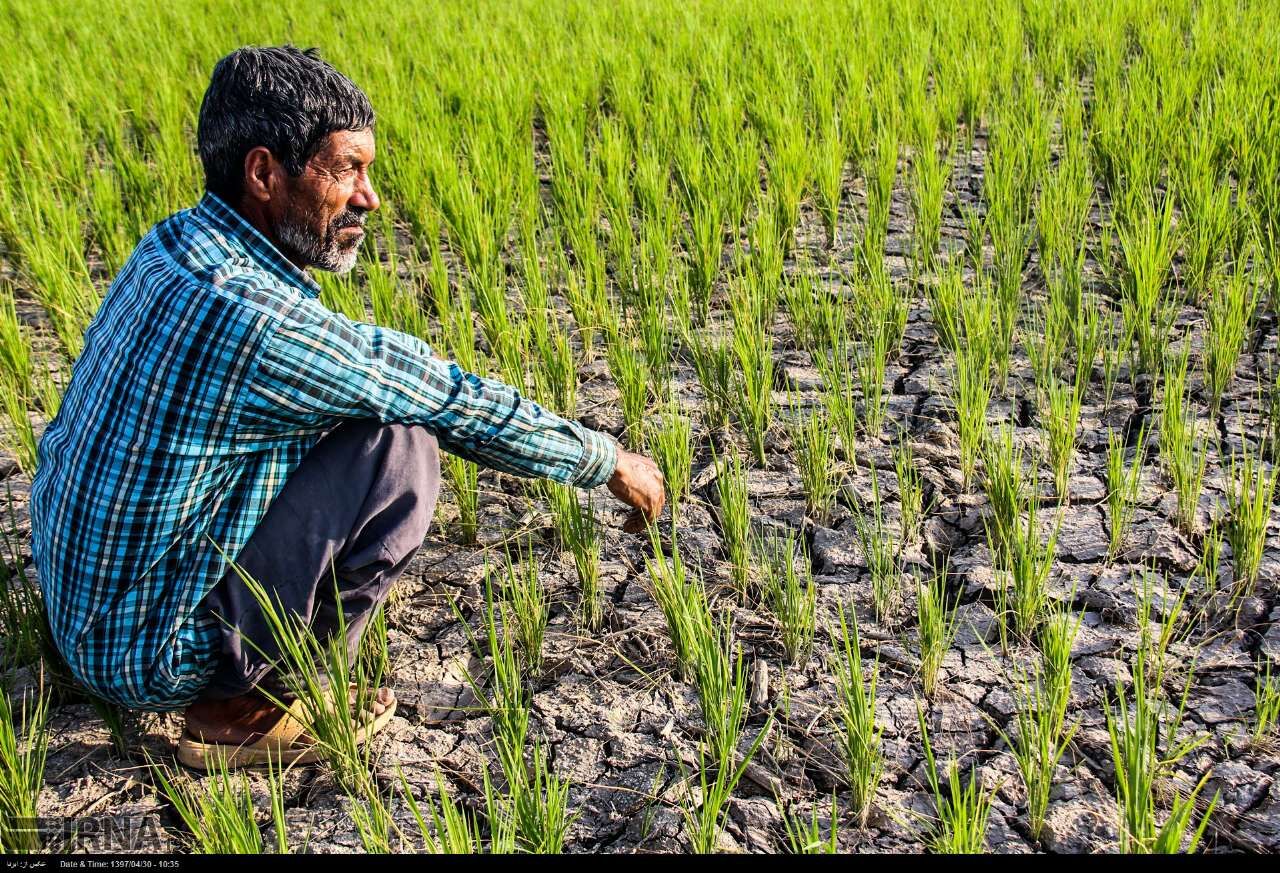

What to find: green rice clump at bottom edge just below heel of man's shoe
left=151, top=757, right=285, bottom=855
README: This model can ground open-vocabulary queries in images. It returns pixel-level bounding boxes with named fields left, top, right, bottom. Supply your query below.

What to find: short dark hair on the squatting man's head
left=196, top=45, right=374, bottom=200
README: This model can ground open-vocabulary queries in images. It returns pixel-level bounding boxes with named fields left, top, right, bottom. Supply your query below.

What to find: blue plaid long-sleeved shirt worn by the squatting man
left=31, top=193, right=617, bottom=710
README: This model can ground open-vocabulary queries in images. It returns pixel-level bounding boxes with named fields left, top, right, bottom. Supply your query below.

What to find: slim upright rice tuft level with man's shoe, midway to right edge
left=835, top=604, right=884, bottom=826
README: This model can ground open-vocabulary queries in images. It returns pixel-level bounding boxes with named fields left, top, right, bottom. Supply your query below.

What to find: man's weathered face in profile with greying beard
left=264, top=128, right=379, bottom=273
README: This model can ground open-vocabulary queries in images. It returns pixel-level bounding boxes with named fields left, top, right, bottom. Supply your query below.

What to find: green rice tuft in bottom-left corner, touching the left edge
left=0, top=682, right=49, bottom=853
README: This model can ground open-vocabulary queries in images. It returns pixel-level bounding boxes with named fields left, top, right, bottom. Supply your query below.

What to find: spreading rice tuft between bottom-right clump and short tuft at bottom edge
left=988, top=671, right=1079, bottom=840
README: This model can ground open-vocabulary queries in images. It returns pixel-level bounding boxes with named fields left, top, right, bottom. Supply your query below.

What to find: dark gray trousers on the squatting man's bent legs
left=204, top=420, right=440, bottom=699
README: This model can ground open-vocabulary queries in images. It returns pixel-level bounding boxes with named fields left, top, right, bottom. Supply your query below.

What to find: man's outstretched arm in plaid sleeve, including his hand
left=241, top=298, right=664, bottom=517
